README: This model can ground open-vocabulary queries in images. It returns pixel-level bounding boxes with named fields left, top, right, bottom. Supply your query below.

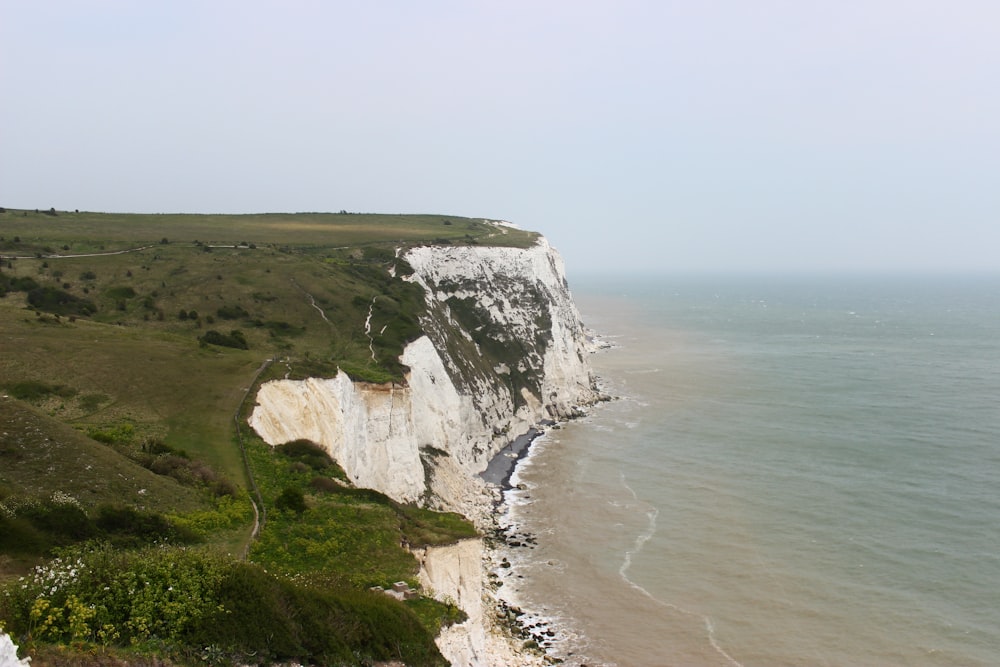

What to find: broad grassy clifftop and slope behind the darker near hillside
left=0, top=209, right=534, bottom=477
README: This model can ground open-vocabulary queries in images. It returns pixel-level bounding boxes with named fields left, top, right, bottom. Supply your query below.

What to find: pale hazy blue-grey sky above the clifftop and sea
left=0, top=0, right=1000, bottom=278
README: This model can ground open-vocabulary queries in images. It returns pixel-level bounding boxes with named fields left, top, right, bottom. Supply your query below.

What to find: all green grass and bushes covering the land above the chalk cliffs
left=0, top=209, right=535, bottom=665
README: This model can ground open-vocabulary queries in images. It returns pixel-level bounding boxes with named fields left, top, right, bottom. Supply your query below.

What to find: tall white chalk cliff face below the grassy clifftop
left=250, top=239, right=596, bottom=510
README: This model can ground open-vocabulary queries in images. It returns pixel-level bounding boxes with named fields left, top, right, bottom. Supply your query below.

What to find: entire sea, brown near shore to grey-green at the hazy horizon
left=503, top=276, right=1000, bottom=667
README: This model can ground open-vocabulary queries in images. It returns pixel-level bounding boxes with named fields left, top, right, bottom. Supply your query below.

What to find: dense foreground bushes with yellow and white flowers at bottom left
left=0, top=545, right=445, bottom=667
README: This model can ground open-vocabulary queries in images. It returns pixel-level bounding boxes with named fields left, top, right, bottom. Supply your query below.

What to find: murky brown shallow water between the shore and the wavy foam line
left=490, top=420, right=735, bottom=667
